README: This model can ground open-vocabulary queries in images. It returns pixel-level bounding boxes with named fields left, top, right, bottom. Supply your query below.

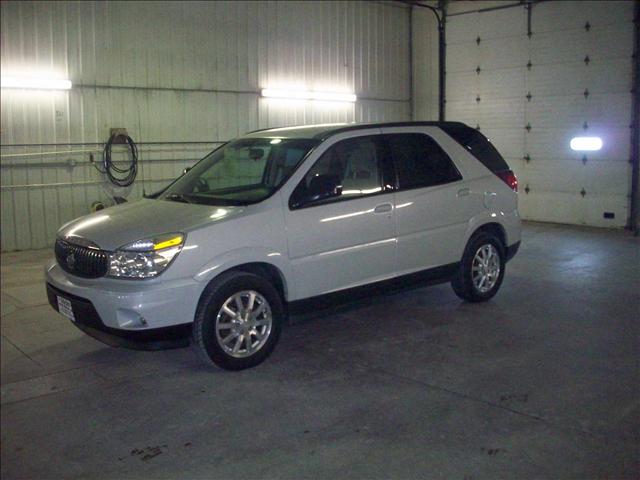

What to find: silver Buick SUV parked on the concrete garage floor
left=46, top=122, right=520, bottom=370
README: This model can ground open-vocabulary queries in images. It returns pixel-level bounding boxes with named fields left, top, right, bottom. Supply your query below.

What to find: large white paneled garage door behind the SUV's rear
left=446, top=1, right=633, bottom=227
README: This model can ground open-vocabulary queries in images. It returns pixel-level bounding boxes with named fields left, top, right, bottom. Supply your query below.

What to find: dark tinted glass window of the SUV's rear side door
left=385, top=133, right=462, bottom=190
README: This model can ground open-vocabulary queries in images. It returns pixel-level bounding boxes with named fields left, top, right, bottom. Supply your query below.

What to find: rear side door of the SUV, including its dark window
left=382, top=127, right=473, bottom=274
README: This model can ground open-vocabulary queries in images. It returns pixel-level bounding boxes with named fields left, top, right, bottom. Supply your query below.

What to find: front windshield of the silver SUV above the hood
left=159, top=138, right=320, bottom=205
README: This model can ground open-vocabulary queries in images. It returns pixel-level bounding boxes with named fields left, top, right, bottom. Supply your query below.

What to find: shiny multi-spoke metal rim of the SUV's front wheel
left=216, top=290, right=273, bottom=358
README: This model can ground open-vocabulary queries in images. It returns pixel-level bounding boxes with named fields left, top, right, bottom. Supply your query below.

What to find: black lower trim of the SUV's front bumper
left=47, top=283, right=191, bottom=350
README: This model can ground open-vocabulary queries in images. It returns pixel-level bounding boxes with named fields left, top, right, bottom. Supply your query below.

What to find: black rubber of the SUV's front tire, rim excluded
left=192, top=271, right=284, bottom=370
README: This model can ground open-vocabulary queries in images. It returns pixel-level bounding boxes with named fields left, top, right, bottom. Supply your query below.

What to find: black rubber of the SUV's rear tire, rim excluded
left=451, top=231, right=506, bottom=302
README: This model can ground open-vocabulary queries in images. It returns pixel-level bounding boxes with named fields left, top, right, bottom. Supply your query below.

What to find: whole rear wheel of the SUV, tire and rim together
left=451, top=231, right=505, bottom=302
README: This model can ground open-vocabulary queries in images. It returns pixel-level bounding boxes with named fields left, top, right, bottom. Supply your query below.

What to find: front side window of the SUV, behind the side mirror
left=289, top=136, right=383, bottom=209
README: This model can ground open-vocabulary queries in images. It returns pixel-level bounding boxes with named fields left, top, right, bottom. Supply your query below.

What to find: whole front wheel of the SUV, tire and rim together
left=192, top=271, right=284, bottom=370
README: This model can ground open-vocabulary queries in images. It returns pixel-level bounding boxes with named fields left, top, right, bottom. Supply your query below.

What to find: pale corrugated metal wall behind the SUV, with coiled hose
left=0, top=1, right=410, bottom=251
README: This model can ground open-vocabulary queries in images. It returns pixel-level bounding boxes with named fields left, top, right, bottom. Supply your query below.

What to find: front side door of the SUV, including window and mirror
left=285, top=135, right=396, bottom=299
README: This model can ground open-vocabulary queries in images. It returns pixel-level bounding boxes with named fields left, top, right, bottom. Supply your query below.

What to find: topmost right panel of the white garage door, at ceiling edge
left=532, top=0, right=633, bottom=34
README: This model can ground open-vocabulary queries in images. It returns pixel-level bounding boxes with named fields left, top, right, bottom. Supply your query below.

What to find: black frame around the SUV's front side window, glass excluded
left=287, top=133, right=397, bottom=211
